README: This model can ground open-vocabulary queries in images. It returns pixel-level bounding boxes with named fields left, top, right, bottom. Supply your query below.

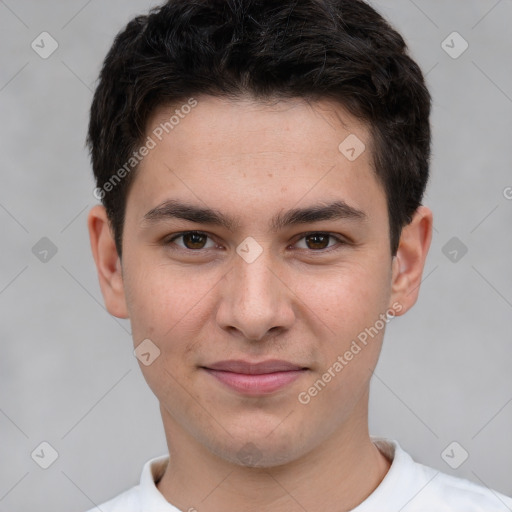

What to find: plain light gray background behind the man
left=0, top=0, right=512, bottom=512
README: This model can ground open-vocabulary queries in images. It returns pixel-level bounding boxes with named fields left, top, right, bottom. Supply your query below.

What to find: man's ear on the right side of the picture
left=390, top=206, right=433, bottom=316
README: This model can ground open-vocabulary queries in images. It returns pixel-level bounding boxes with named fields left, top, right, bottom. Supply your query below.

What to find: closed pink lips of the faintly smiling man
left=202, top=359, right=307, bottom=396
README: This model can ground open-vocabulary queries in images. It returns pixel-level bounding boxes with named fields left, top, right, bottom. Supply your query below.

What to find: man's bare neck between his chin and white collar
left=157, top=402, right=390, bottom=512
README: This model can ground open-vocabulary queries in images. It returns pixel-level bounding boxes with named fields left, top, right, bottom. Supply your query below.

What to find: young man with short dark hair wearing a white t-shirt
left=88, top=0, right=512, bottom=512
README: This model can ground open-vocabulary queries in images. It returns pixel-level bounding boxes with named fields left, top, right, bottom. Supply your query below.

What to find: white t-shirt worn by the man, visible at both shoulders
left=87, top=437, right=512, bottom=512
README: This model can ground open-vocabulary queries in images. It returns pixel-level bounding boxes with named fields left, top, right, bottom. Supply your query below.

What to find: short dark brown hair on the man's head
left=87, top=0, right=431, bottom=257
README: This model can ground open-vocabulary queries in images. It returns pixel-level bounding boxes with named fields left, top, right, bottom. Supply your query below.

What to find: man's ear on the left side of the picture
left=87, top=205, right=128, bottom=318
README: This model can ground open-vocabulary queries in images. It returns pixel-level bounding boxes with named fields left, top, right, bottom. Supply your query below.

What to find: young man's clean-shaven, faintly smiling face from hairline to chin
left=89, top=97, right=428, bottom=466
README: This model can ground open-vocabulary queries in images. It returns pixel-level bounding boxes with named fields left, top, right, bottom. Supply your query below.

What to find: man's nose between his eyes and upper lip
left=217, top=249, right=295, bottom=341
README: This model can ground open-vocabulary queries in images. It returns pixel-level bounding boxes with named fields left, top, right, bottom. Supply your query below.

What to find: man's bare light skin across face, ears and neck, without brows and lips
left=88, top=96, right=432, bottom=512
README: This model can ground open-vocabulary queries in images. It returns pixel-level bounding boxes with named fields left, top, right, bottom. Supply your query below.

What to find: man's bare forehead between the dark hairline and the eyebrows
left=127, top=96, right=386, bottom=230
